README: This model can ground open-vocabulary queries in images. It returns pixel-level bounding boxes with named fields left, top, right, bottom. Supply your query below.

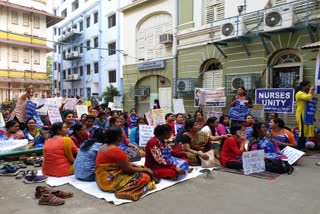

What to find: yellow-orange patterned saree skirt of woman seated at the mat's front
left=95, top=163, right=156, bottom=201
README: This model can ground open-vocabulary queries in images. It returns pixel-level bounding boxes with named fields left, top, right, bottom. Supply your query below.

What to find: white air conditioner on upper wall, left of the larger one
left=220, top=17, right=247, bottom=40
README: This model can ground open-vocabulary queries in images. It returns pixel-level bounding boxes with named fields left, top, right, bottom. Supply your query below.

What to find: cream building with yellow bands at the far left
left=0, top=0, right=61, bottom=101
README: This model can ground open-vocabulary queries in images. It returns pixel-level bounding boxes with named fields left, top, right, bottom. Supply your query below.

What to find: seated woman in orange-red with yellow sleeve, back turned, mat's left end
left=42, top=122, right=78, bottom=177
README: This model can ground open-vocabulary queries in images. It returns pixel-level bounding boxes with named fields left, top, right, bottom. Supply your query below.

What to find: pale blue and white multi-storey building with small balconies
left=52, top=0, right=122, bottom=97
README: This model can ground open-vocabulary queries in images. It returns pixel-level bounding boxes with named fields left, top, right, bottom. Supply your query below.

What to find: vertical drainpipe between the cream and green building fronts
left=172, top=0, right=179, bottom=97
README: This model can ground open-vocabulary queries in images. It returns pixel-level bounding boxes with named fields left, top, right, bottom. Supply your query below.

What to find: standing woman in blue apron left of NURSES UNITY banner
left=229, top=87, right=253, bottom=125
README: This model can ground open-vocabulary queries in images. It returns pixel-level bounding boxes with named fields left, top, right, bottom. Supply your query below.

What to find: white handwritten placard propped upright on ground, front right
left=242, top=150, right=266, bottom=175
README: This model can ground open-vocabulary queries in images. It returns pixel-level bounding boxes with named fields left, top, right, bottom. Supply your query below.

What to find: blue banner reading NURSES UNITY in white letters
left=256, top=88, right=294, bottom=113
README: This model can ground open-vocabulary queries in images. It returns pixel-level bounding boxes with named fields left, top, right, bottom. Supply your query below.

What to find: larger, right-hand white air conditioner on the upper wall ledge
left=264, top=5, right=295, bottom=31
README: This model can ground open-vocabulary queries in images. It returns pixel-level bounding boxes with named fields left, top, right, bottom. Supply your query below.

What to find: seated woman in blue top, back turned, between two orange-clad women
left=74, top=128, right=104, bottom=181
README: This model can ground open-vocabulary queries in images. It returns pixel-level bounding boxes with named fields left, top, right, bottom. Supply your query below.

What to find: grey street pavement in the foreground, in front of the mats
left=0, top=157, right=320, bottom=214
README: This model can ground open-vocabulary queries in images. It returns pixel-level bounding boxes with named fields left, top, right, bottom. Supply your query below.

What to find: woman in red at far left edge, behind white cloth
left=0, top=120, right=24, bottom=141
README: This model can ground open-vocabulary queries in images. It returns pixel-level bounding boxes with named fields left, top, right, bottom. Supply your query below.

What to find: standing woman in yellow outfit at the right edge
left=295, top=80, right=315, bottom=149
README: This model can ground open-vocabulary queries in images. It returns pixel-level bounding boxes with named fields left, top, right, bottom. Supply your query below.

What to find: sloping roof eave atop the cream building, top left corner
left=0, top=1, right=64, bottom=28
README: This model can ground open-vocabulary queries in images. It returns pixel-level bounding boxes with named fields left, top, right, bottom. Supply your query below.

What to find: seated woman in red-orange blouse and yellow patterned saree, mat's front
left=95, top=127, right=156, bottom=201
